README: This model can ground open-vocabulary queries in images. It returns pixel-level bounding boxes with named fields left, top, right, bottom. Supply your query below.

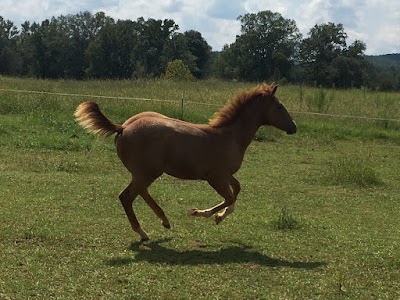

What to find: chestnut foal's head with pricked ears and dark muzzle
left=262, top=85, right=297, bottom=134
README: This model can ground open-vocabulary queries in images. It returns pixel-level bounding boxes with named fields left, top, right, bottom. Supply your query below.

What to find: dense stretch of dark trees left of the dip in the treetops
left=0, top=12, right=211, bottom=79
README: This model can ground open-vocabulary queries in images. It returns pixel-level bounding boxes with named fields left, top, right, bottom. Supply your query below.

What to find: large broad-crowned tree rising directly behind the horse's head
left=219, top=11, right=301, bottom=81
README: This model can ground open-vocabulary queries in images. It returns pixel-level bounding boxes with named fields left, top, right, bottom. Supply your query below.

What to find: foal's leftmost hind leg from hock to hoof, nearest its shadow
left=119, top=180, right=149, bottom=241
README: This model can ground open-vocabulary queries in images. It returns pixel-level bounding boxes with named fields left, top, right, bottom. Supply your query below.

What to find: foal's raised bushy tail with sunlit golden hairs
left=74, top=102, right=124, bottom=137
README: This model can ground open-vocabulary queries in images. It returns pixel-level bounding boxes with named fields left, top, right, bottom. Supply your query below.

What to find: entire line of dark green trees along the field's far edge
left=0, top=11, right=400, bottom=89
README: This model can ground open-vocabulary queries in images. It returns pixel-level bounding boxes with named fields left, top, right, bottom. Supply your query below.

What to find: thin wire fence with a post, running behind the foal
left=0, top=88, right=400, bottom=122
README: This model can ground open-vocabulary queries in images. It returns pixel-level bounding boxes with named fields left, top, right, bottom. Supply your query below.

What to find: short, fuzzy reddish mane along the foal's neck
left=209, top=84, right=274, bottom=128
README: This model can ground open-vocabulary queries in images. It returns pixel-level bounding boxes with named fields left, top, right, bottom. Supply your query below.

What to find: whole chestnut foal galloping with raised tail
left=74, top=84, right=297, bottom=242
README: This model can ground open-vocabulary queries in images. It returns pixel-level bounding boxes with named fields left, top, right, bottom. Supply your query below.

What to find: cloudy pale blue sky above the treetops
left=0, top=0, right=400, bottom=55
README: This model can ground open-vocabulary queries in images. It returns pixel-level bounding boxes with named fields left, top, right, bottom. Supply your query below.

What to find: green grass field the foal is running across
left=0, top=77, right=400, bottom=299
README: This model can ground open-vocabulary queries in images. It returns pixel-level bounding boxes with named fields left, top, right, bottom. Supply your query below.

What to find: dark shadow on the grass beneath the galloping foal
left=106, top=239, right=326, bottom=270
